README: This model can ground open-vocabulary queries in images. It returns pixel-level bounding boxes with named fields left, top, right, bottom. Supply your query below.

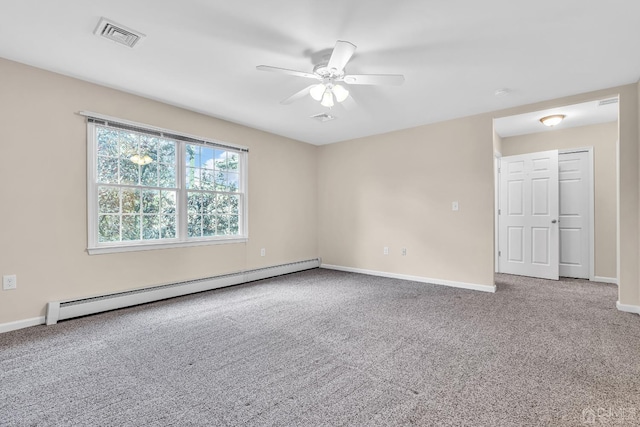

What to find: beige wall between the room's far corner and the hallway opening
left=318, top=115, right=493, bottom=286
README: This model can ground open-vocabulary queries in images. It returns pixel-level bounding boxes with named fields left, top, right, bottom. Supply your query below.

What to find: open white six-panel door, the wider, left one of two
left=498, top=150, right=559, bottom=280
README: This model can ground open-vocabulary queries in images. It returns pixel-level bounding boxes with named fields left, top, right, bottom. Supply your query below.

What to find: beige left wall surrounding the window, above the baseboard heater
left=0, top=59, right=318, bottom=324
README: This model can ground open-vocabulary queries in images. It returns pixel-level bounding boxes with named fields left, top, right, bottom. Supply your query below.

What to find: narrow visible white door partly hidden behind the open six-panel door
left=558, top=151, right=591, bottom=279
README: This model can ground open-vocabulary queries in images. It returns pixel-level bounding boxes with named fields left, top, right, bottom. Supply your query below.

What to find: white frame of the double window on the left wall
left=80, top=111, right=249, bottom=255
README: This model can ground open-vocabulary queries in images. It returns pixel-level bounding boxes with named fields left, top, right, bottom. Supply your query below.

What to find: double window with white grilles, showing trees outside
left=83, top=113, right=247, bottom=254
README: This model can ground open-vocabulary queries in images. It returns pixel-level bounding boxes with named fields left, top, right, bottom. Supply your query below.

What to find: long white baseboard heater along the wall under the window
left=46, top=259, right=320, bottom=325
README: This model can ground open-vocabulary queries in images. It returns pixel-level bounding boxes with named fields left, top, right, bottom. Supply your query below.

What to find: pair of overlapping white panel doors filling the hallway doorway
left=497, top=148, right=594, bottom=280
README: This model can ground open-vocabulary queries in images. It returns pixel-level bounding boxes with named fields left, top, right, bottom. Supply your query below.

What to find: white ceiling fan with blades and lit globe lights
left=256, top=40, right=404, bottom=108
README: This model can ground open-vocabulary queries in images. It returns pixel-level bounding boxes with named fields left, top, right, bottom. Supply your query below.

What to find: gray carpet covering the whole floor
left=0, top=269, right=640, bottom=426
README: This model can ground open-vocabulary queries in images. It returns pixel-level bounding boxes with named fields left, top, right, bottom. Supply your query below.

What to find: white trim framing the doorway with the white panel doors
left=493, top=147, right=596, bottom=281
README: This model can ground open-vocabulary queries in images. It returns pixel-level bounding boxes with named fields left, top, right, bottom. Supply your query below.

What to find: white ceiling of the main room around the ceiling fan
left=0, top=0, right=640, bottom=144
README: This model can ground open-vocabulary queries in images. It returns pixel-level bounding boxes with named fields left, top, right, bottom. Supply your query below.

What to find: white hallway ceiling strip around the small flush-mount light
left=493, top=97, right=618, bottom=138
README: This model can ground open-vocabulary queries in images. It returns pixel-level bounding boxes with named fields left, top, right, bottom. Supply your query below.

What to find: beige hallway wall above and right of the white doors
left=502, top=122, right=618, bottom=278
